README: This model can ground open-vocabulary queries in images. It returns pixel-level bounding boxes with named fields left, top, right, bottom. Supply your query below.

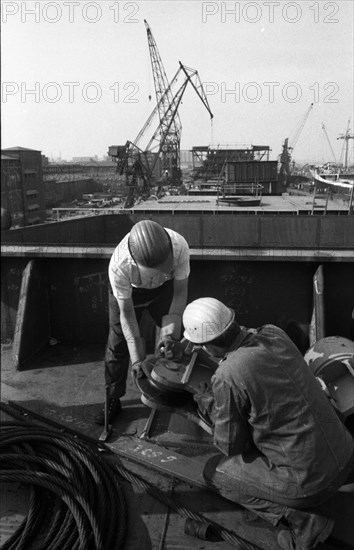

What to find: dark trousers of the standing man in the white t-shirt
left=104, top=279, right=173, bottom=397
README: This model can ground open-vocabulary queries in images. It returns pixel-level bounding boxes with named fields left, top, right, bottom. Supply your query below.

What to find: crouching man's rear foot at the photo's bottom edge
left=278, top=510, right=334, bottom=550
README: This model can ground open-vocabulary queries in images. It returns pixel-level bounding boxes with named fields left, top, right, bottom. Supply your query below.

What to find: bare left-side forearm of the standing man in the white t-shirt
left=118, top=298, right=145, bottom=374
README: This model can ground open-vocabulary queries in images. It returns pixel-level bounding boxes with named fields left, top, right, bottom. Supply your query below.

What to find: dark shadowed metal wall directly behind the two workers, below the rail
left=1, top=257, right=354, bottom=351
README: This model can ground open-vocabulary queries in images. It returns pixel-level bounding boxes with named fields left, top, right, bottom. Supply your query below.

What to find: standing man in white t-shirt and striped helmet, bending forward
left=95, top=220, right=190, bottom=424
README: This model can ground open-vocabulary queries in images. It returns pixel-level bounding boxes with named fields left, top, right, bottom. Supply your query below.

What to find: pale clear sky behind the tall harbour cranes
left=1, top=0, right=354, bottom=163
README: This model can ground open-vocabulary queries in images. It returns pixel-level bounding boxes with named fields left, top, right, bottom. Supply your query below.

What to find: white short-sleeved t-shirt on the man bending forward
left=108, top=227, right=190, bottom=299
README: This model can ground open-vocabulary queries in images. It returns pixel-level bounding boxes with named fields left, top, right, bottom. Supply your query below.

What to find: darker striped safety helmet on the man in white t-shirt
left=128, top=220, right=172, bottom=267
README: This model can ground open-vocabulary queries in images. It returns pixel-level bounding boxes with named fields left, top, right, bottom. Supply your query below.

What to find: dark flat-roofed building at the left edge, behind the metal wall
left=1, top=147, right=46, bottom=226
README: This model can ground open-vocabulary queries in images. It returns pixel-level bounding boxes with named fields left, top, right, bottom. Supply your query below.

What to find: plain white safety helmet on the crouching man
left=182, top=298, right=235, bottom=344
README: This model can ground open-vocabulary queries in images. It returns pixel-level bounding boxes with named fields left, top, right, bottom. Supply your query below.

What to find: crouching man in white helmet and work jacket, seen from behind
left=183, top=298, right=354, bottom=550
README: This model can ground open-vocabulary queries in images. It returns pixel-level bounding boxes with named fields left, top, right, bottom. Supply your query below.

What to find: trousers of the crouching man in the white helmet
left=204, top=450, right=353, bottom=525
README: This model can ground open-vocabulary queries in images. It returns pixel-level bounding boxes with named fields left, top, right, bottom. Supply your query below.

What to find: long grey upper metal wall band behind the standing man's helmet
left=2, top=212, right=354, bottom=250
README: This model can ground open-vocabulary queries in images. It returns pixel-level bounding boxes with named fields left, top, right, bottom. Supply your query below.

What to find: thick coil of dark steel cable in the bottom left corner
left=0, top=422, right=127, bottom=550
